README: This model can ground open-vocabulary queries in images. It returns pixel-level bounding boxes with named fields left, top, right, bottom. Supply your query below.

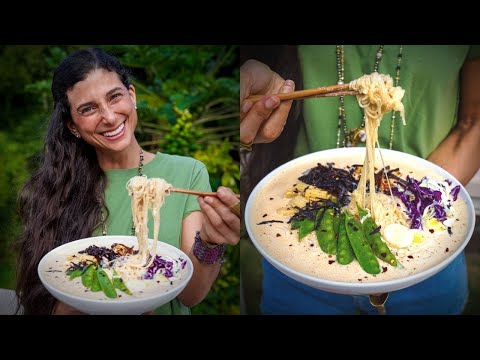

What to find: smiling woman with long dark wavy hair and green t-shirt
left=17, top=49, right=239, bottom=314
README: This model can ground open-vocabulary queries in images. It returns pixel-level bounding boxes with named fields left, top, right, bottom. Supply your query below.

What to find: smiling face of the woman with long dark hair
left=67, top=69, right=137, bottom=152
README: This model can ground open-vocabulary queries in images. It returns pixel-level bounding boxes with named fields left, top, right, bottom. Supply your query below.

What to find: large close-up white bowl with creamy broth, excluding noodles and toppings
left=245, top=148, right=475, bottom=295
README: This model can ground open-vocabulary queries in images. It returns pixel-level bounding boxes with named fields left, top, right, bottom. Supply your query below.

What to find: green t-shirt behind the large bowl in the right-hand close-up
left=295, top=45, right=478, bottom=158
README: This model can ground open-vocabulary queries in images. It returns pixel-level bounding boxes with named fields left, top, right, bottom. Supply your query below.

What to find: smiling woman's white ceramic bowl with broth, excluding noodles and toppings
left=38, top=236, right=193, bottom=315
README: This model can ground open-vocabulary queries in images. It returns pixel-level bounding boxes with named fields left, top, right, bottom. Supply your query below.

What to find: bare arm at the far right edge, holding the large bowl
left=427, top=58, right=480, bottom=185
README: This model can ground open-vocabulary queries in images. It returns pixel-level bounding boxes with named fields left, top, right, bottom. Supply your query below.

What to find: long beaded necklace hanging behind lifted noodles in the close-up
left=336, top=45, right=403, bottom=149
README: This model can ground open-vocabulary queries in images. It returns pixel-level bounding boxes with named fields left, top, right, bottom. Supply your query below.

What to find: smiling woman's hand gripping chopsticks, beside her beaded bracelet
left=197, top=186, right=240, bottom=245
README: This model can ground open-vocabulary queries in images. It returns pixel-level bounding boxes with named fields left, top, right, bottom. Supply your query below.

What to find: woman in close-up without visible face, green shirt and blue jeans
left=240, top=45, right=480, bottom=314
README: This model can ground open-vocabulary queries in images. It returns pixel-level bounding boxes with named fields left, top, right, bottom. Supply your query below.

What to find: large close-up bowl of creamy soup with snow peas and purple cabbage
left=245, top=148, right=475, bottom=295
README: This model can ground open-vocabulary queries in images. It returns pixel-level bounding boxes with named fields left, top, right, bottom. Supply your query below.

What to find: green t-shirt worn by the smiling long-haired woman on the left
left=100, top=153, right=211, bottom=315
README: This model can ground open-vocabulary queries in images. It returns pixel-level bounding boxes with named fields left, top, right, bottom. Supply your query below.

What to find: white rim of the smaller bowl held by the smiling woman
left=37, top=235, right=193, bottom=306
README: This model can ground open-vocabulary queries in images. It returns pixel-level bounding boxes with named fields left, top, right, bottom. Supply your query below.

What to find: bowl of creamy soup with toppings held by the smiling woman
left=38, top=236, right=193, bottom=315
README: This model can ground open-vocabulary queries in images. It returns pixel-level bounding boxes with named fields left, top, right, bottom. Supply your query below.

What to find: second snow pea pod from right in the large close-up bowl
left=345, top=211, right=380, bottom=274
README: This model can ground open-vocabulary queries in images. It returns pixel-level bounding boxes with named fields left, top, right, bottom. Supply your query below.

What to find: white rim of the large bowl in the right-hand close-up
left=244, top=147, right=475, bottom=295
